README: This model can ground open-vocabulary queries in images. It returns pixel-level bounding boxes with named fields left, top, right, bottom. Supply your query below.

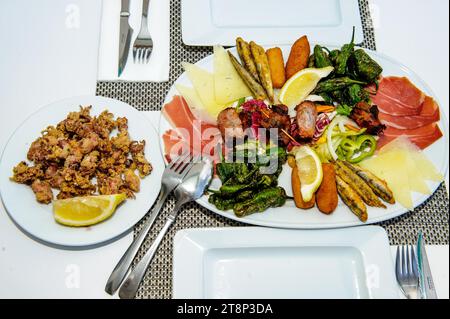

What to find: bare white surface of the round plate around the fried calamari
left=0, top=96, right=165, bottom=247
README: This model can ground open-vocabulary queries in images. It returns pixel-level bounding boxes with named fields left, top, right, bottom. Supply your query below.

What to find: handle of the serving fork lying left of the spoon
left=105, top=186, right=169, bottom=295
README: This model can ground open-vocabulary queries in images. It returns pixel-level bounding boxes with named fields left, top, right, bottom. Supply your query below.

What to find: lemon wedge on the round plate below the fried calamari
left=53, top=194, right=126, bottom=227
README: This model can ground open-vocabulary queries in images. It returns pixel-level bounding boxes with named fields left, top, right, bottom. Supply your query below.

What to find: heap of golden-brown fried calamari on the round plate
left=11, top=107, right=152, bottom=204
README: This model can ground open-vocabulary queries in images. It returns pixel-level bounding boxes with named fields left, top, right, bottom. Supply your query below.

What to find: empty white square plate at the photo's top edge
left=181, top=0, right=364, bottom=46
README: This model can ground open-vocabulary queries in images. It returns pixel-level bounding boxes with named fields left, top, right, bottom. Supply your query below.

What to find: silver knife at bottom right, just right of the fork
left=417, top=232, right=438, bottom=299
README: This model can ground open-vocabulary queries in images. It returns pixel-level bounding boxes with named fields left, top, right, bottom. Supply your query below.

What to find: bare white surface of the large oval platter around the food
left=159, top=46, right=449, bottom=229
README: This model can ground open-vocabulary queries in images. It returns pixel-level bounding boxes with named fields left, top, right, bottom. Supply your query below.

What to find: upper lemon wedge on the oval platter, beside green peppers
left=279, top=66, right=334, bottom=109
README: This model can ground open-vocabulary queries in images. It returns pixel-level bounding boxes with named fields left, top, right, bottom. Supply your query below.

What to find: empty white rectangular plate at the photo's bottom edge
left=173, top=226, right=399, bottom=299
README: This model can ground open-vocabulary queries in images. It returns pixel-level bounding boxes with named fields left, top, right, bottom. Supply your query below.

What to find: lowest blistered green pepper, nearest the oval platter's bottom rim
left=233, top=187, right=287, bottom=217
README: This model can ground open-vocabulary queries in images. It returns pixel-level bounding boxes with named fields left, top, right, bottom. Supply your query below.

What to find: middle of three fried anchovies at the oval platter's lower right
left=335, top=161, right=386, bottom=208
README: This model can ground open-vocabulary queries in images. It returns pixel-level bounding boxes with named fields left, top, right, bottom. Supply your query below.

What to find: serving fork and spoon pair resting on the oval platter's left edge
left=105, top=153, right=213, bottom=299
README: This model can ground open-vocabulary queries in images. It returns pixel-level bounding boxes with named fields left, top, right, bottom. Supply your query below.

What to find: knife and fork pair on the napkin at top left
left=118, top=0, right=153, bottom=77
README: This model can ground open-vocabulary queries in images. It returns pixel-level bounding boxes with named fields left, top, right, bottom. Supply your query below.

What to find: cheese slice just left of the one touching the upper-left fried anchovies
left=182, top=62, right=225, bottom=119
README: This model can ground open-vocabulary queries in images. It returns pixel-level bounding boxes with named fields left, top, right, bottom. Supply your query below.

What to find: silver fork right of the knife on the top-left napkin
left=133, top=0, right=153, bottom=63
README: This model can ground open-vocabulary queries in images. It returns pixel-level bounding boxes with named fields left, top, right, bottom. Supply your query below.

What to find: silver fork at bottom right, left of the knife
left=395, top=245, right=419, bottom=299
